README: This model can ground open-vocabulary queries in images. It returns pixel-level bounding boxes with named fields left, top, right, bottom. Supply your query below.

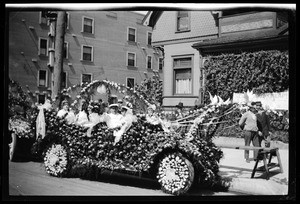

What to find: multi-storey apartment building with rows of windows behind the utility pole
left=8, top=11, right=163, bottom=103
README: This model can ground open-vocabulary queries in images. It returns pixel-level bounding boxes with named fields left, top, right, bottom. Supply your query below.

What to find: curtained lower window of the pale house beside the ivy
left=173, top=57, right=192, bottom=94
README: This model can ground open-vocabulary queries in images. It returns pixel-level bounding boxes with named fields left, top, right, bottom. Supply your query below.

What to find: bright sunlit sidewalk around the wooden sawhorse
left=214, top=137, right=289, bottom=195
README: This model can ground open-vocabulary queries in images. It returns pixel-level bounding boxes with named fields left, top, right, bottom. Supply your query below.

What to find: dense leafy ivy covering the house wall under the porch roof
left=204, top=50, right=289, bottom=103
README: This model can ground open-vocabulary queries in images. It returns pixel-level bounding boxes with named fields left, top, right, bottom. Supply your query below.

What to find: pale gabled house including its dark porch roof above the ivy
left=143, top=10, right=288, bottom=106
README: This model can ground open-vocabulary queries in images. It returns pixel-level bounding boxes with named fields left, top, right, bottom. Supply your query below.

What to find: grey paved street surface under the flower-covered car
left=9, top=162, right=241, bottom=196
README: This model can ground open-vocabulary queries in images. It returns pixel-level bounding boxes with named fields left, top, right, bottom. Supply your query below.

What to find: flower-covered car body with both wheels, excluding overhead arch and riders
left=39, top=102, right=230, bottom=195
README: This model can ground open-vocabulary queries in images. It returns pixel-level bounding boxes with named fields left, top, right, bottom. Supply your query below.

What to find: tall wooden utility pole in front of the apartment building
left=51, top=11, right=66, bottom=106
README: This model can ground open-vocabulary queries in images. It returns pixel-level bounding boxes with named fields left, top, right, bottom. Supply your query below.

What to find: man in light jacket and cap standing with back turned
left=239, top=102, right=261, bottom=163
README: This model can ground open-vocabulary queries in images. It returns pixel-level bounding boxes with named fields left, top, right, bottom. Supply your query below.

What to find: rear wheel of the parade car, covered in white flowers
left=44, top=144, right=68, bottom=176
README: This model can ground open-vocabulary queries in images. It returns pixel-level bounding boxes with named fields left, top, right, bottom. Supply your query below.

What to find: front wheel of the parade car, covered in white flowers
left=157, top=153, right=194, bottom=195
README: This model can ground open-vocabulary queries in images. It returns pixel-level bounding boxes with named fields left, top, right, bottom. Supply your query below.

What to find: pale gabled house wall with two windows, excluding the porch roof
left=152, top=11, right=218, bottom=107
